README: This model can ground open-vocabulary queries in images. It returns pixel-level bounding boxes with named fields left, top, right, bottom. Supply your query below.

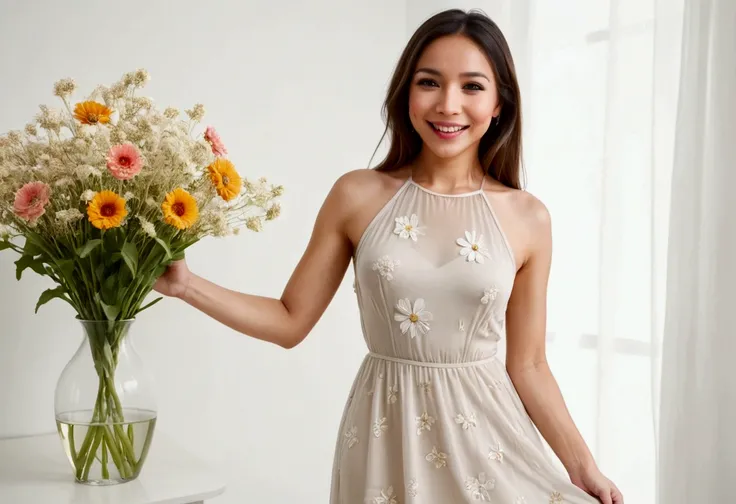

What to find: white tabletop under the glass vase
left=0, top=432, right=225, bottom=504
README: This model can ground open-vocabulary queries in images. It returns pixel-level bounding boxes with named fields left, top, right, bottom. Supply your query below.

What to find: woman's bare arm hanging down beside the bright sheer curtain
left=506, top=200, right=594, bottom=480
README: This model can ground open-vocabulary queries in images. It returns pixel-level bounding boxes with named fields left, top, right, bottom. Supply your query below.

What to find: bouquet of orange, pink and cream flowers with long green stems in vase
left=0, top=70, right=283, bottom=481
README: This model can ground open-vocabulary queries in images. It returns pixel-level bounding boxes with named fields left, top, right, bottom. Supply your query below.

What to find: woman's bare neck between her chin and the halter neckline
left=411, top=148, right=485, bottom=192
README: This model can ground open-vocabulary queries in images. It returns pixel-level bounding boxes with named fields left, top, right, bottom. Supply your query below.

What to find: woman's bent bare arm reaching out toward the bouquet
left=172, top=172, right=352, bottom=348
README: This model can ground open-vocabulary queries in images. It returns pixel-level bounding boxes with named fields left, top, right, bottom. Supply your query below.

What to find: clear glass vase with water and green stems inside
left=54, top=320, right=157, bottom=485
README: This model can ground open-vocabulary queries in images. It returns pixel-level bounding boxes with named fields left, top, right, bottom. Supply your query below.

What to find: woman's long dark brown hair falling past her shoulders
left=374, top=9, right=524, bottom=189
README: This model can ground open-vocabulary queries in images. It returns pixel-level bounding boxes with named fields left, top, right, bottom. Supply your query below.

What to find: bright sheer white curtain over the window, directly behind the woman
left=407, top=0, right=683, bottom=504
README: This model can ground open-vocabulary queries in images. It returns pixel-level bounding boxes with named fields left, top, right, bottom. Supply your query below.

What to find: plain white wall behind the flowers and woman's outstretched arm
left=0, top=0, right=407, bottom=503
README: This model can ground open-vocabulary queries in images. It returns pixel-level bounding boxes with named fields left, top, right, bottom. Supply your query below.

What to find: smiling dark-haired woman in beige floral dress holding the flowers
left=156, top=10, right=623, bottom=504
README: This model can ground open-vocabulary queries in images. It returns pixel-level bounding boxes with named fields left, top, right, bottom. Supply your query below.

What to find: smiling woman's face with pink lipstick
left=409, top=35, right=500, bottom=159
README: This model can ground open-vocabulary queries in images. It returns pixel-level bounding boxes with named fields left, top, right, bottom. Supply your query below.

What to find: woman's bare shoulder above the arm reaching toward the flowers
left=328, top=168, right=407, bottom=252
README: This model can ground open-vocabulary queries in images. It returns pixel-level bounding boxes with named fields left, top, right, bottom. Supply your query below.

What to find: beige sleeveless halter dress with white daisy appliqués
left=330, top=175, right=598, bottom=504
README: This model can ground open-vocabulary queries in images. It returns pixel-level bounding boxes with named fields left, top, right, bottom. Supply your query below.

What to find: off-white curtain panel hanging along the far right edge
left=658, top=0, right=736, bottom=504
